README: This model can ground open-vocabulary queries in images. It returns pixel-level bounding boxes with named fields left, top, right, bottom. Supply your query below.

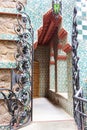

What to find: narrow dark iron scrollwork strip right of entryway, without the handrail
left=72, top=8, right=83, bottom=130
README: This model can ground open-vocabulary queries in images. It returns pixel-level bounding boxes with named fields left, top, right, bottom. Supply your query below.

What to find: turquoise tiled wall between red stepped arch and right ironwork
left=62, top=0, right=75, bottom=44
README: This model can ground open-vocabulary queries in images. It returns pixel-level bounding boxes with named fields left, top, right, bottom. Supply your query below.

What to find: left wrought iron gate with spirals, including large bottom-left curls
left=0, top=2, right=33, bottom=130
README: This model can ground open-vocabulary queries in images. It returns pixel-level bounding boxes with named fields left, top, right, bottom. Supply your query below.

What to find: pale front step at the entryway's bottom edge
left=20, top=121, right=77, bottom=130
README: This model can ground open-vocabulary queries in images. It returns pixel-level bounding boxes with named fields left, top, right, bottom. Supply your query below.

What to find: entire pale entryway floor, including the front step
left=20, top=98, right=77, bottom=130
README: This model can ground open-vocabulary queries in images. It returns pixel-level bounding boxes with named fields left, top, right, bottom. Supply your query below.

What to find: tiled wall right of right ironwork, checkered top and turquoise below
left=76, top=0, right=87, bottom=93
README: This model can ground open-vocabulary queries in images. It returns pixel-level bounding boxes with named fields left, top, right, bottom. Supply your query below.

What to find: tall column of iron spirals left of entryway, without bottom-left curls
left=12, top=2, right=33, bottom=129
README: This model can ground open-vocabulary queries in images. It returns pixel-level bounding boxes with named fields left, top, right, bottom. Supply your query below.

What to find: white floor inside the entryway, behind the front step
left=33, top=98, right=73, bottom=121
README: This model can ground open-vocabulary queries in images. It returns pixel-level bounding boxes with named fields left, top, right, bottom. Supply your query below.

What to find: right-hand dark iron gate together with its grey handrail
left=72, top=8, right=87, bottom=130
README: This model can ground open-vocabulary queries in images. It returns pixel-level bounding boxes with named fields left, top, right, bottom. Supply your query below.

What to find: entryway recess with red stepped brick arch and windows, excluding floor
left=33, top=10, right=73, bottom=115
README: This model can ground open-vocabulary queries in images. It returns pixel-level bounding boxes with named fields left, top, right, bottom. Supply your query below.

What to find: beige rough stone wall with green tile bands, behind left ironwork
left=0, top=0, right=27, bottom=127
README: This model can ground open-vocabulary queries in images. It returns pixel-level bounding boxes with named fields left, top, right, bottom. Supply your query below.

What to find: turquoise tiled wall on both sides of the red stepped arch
left=26, top=0, right=75, bottom=43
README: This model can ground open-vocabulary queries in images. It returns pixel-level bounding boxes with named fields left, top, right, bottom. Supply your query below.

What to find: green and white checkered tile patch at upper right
left=76, top=0, right=87, bottom=40
